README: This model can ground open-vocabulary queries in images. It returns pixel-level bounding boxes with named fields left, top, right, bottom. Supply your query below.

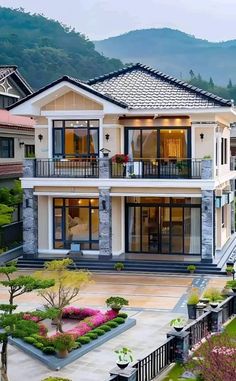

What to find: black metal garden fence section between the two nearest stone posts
left=133, top=337, right=175, bottom=381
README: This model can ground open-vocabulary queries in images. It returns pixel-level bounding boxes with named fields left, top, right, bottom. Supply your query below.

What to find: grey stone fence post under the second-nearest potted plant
left=167, top=331, right=190, bottom=363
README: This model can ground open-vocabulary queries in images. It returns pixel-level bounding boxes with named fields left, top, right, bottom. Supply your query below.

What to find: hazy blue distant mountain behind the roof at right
left=94, top=26, right=236, bottom=85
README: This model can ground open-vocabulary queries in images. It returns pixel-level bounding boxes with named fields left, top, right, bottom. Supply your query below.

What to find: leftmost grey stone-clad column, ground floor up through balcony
left=23, top=159, right=38, bottom=258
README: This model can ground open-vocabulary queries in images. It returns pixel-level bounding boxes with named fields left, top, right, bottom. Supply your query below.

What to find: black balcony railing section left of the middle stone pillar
left=35, top=157, right=99, bottom=178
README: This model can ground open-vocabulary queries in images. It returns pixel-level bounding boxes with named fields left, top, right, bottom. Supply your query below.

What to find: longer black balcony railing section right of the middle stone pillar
left=111, top=158, right=202, bottom=179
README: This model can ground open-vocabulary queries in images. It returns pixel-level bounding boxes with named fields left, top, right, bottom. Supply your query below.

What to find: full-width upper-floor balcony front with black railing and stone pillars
left=31, top=157, right=212, bottom=180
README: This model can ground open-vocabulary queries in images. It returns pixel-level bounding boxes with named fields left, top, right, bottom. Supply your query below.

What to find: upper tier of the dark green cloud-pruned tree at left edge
left=0, top=261, right=55, bottom=313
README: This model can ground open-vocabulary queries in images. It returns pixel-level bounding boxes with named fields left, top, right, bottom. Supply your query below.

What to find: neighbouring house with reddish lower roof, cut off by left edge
left=0, top=66, right=34, bottom=186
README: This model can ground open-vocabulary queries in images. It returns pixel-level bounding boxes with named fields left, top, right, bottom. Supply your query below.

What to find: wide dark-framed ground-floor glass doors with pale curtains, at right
left=126, top=197, right=201, bottom=254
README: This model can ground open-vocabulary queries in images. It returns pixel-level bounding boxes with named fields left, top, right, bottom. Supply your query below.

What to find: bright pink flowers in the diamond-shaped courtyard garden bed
left=51, top=306, right=117, bottom=339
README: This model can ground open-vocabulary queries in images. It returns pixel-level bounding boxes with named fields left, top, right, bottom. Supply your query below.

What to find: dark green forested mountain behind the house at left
left=0, top=7, right=123, bottom=89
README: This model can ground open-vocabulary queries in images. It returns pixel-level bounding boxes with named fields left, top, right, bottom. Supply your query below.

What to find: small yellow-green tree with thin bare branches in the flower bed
left=34, top=258, right=91, bottom=333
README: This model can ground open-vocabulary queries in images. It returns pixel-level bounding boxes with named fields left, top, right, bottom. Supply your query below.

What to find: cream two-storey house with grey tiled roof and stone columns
left=10, top=64, right=236, bottom=262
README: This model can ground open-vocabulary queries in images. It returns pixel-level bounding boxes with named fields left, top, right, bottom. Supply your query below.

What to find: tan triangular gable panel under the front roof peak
left=42, top=91, right=103, bottom=111
